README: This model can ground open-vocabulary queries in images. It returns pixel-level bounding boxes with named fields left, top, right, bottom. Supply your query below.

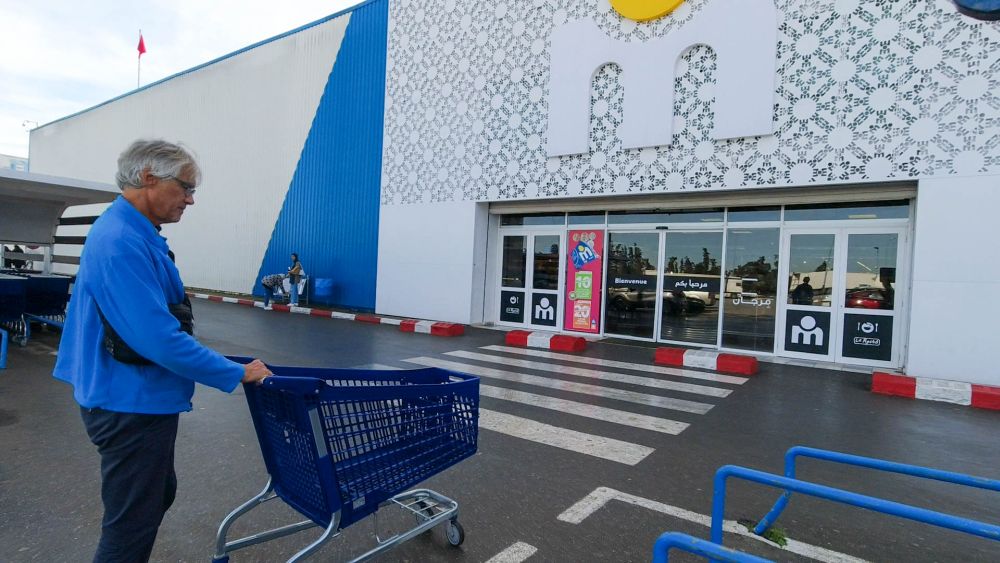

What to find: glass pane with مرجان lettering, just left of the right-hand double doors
left=722, top=229, right=780, bottom=352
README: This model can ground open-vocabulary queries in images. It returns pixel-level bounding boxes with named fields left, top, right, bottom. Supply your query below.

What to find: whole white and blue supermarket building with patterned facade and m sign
left=23, top=0, right=1000, bottom=385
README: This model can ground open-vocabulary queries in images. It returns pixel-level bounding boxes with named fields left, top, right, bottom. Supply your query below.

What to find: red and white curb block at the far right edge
left=872, top=371, right=1000, bottom=410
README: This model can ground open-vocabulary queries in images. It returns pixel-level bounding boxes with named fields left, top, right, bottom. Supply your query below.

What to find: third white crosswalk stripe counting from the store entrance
left=403, top=356, right=713, bottom=414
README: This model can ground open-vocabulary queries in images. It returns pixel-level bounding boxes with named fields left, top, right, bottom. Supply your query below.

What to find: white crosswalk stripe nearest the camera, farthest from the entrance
left=479, top=408, right=656, bottom=465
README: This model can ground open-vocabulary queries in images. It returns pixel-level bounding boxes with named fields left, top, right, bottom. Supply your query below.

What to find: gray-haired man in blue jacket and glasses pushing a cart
left=53, top=140, right=271, bottom=563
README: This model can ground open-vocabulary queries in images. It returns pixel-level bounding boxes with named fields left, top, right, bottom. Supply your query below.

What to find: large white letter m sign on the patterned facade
left=547, top=0, right=778, bottom=157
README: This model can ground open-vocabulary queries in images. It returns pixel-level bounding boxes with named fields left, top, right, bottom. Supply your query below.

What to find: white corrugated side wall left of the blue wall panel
left=30, top=13, right=350, bottom=293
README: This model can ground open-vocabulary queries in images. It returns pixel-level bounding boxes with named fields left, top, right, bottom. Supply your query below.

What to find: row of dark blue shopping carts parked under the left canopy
left=0, top=270, right=72, bottom=369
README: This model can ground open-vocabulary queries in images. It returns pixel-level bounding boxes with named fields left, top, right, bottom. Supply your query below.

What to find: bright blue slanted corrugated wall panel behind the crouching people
left=254, top=0, right=389, bottom=310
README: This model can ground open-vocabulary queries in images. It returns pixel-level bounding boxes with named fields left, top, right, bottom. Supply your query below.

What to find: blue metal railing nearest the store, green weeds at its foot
left=754, top=446, right=1000, bottom=535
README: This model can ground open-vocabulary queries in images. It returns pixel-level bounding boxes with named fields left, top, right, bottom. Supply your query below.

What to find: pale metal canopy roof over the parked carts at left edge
left=0, top=170, right=121, bottom=244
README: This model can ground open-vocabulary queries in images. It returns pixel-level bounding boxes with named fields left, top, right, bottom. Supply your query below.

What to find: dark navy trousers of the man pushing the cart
left=81, top=408, right=178, bottom=563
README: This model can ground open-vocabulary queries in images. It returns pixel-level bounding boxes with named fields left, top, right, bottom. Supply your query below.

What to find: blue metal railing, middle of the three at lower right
left=711, top=465, right=1000, bottom=545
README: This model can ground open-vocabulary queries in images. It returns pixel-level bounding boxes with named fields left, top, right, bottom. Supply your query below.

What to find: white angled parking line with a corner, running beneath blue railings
left=556, top=487, right=866, bottom=563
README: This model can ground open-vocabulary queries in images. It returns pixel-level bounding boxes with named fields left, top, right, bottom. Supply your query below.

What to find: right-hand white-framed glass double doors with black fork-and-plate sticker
left=778, top=227, right=906, bottom=367
